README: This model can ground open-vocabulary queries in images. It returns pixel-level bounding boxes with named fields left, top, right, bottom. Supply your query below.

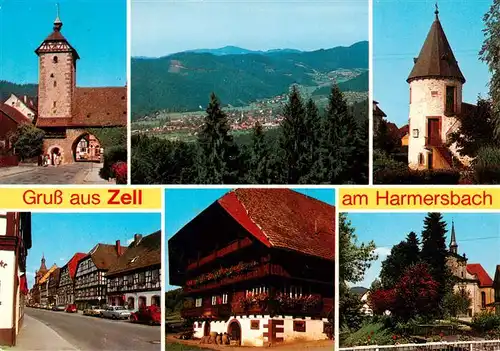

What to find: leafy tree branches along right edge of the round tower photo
left=479, top=0, right=500, bottom=140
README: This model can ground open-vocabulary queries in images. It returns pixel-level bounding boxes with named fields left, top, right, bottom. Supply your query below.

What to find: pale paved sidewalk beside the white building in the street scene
left=12, top=314, right=78, bottom=351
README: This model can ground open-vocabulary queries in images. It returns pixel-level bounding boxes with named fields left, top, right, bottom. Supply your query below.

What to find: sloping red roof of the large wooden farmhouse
left=217, top=189, right=335, bottom=261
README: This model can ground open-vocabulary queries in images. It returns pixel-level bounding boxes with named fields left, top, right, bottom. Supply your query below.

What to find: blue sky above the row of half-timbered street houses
left=26, top=213, right=161, bottom=288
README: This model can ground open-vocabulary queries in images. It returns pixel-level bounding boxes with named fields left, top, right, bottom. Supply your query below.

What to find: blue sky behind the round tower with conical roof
left=373, top=0, right=492, bottom=126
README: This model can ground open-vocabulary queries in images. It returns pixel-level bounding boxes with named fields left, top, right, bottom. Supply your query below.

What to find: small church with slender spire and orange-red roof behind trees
left=447, top=222, right=495, bottom=317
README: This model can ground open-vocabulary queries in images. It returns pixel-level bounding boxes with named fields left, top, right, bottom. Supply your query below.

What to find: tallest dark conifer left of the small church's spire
left=421, top=212, right=453, bottom=312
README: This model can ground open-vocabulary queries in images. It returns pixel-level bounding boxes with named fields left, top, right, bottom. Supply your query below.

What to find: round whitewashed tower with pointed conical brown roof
left=407, top=4, right=465, bottom=169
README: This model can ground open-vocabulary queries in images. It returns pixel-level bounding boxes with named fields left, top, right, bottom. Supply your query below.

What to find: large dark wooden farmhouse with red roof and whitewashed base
left=168, top=189, right=335, bottom=346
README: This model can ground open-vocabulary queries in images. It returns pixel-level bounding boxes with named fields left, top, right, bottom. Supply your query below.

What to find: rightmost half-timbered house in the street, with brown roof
left=106, top=231, right=161, bottom=311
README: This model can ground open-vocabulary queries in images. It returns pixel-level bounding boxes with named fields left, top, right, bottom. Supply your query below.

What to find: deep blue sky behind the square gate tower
left=0, top=0, right=127, bottom=86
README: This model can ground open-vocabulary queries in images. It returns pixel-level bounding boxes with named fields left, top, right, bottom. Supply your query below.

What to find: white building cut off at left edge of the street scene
left=0, top=212, right=31, bottom=348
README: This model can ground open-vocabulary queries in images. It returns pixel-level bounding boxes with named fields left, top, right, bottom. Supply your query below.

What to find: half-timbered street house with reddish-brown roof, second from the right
left=75, top=240, right=126, bottom=310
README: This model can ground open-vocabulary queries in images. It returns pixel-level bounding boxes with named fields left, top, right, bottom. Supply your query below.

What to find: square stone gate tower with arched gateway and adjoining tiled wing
left=35, top=9, right=127, bottom=164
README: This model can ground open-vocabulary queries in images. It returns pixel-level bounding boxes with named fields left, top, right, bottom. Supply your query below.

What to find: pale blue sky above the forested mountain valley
left=132, top=0, right=368, bottom=57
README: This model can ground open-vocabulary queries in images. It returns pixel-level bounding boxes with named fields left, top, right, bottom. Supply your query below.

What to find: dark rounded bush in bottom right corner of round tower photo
left=473, top=146, right=500, bottom=184
